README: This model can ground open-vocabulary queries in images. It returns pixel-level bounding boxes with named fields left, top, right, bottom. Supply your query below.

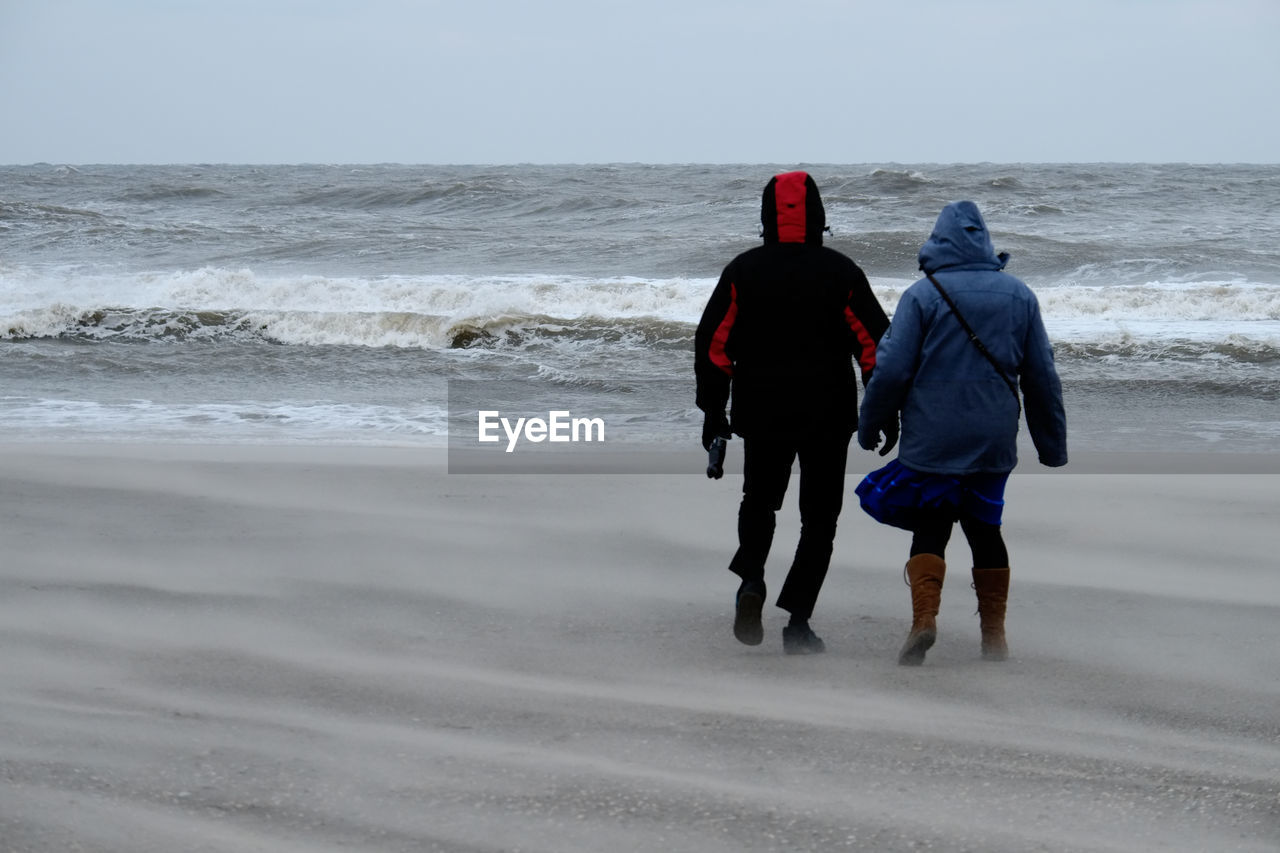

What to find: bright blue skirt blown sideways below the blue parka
left=854, top=459, right=1009, bottom=530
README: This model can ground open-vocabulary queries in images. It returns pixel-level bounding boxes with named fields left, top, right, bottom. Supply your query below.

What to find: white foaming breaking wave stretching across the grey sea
left=0, top=268, right=1280, bottom=364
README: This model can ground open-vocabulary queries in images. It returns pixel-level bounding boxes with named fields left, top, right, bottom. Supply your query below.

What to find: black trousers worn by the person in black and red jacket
left=728, top=432, right=851, bottom=619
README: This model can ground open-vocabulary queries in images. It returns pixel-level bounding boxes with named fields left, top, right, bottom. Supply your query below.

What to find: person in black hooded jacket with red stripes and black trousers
left=694, top=172, right=896, bottom=654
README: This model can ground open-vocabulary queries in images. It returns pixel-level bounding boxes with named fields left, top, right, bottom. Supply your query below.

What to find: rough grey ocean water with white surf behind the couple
left=0, top=164, right=1280, bottom=452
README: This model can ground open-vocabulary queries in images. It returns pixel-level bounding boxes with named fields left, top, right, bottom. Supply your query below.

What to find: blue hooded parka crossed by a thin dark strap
left=858, top=201, right=1066, bottom=475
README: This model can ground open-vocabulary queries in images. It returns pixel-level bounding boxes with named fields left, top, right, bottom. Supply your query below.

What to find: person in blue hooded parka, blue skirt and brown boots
left=858, top=201, right=1066, bottom=665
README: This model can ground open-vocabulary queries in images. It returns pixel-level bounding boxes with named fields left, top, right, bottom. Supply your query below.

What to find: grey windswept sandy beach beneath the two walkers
left=0, top=444, right=1280, bottom=853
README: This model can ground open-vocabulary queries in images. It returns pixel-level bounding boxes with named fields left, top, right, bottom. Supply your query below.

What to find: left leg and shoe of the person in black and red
left=728, top=439, right=795, bottom=646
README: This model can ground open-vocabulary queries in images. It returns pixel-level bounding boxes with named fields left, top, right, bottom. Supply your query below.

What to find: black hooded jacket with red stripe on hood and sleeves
left=694, top=172, right=888, bottom=437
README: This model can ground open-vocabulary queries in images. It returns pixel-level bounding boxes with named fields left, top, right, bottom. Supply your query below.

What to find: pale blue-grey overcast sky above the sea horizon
left=0, top=0, right=1280, bottom=164
